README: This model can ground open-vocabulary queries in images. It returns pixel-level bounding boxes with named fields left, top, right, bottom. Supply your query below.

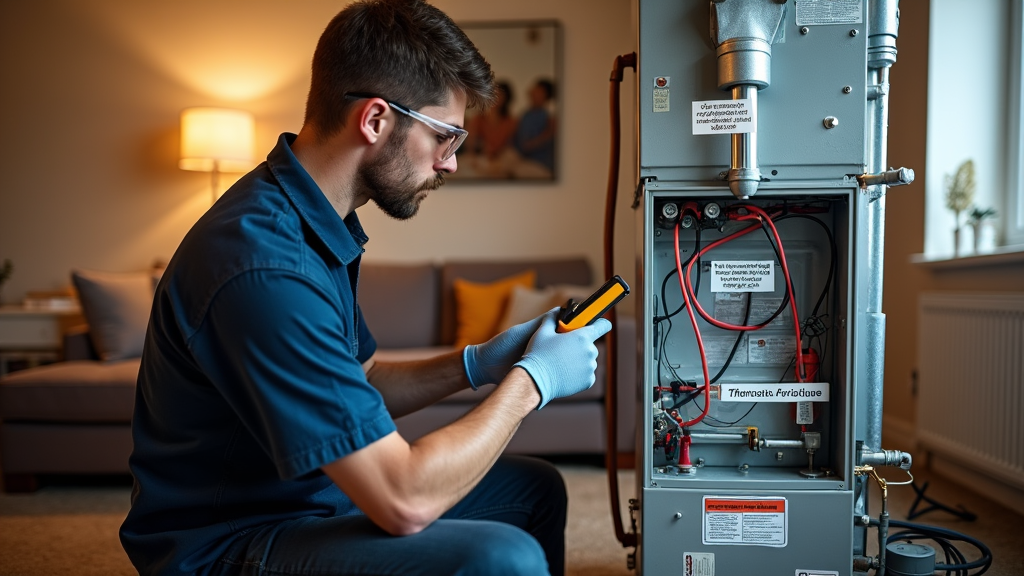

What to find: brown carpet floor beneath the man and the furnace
left=0, top=463, right=1024, bottom=576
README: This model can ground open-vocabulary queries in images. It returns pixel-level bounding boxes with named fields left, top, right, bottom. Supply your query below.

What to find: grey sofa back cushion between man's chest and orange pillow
left=358, top=262, right=440, bottom=348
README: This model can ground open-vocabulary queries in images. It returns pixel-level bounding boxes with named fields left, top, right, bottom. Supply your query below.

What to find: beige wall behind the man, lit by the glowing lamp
left=0, top=0, right=635, bottom=309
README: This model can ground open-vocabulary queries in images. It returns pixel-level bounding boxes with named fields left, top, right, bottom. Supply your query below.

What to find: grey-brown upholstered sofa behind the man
left=0, top=258, right=636, bottom=491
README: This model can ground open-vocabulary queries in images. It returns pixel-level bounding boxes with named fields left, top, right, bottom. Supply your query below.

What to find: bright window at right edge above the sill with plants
left=925, top=0, right=1024, bottom=258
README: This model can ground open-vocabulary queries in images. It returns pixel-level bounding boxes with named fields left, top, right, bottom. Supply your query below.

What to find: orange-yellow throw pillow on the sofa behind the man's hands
left=452, top=270, right=537, bottom=348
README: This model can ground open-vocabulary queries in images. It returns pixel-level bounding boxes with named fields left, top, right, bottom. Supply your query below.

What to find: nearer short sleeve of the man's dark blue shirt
left=189, top=270, right=395, bottom=479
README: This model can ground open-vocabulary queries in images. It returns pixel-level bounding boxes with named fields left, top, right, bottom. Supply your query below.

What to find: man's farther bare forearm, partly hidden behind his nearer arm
left=367, top=351, right=469, bottom=418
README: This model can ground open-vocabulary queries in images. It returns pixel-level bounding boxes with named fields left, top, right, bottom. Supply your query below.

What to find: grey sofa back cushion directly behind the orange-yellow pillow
left=439, top=257, right=593, bottom=344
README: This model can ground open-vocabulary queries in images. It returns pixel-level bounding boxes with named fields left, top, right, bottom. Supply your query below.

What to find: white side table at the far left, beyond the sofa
left=0, top=305, right=85, bottom=376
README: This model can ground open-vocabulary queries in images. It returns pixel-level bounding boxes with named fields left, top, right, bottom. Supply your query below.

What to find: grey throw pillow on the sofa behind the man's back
left=71, top=270, right=153, bottom=361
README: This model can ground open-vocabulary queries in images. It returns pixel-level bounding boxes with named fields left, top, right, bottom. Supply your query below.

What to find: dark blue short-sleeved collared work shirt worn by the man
left=121, top=134, right=395, bottom=574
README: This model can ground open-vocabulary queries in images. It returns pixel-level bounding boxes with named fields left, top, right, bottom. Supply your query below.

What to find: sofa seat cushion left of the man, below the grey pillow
left=0, top=358, right=141, bottom=423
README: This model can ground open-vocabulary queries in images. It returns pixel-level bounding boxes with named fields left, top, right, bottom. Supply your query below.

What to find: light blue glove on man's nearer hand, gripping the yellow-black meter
left=515, top=311, right=611, bottom=410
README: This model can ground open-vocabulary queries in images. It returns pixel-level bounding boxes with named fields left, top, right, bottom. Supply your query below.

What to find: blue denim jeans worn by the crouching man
left=211, top=456, right=566, bottom=576
